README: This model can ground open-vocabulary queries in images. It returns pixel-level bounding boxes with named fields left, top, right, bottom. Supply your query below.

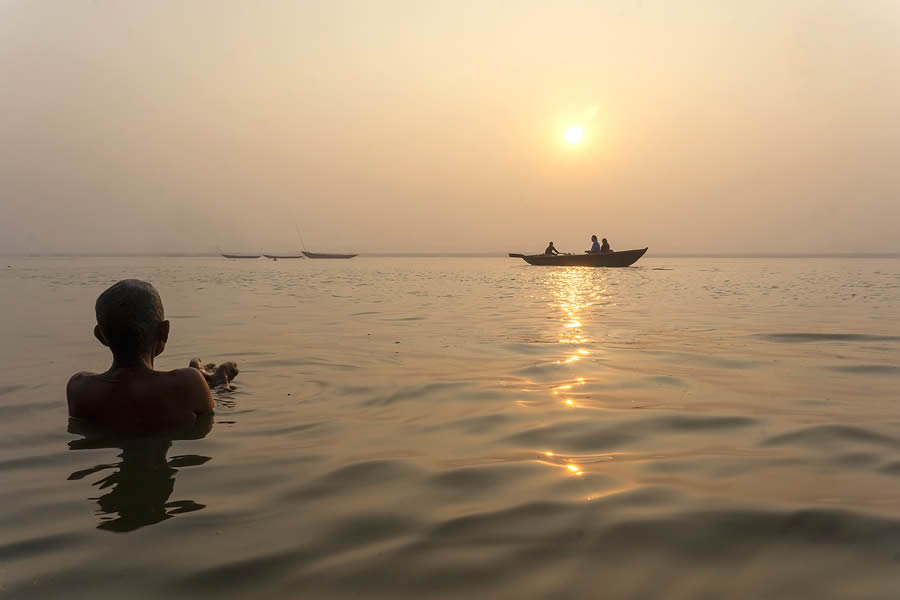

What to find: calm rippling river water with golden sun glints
left=0, top=254, right=900, bottom=599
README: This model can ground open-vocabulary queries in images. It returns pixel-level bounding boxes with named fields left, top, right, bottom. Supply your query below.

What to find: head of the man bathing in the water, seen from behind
left=95, top=279, right=168, bottom=360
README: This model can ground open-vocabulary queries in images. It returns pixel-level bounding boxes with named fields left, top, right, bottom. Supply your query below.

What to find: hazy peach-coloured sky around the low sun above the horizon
left=0, top=0, right=900, bottom=252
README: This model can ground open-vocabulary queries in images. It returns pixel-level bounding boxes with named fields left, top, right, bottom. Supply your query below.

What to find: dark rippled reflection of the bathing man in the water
left=69, top=418, right=212, bottom=532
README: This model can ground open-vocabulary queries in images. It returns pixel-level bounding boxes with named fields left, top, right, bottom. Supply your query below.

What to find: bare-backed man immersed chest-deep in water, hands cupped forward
left=66, top=279, right=238, bottom=431
